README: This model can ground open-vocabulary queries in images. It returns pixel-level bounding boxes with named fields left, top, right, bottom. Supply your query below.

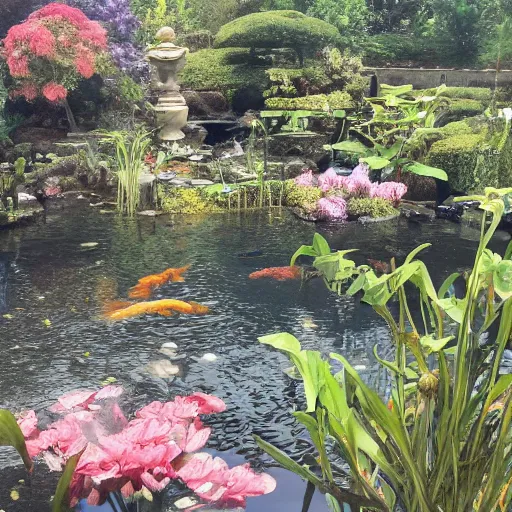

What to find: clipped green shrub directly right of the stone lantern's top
left=181, top=48, right=269, bottom=94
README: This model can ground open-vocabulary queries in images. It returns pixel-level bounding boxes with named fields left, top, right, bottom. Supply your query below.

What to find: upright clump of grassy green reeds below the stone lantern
left=101, top=129, right=151, bottom=216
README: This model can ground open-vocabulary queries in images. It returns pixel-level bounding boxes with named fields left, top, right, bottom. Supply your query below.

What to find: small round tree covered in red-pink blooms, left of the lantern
left=3, top=3, right=107, bottom=130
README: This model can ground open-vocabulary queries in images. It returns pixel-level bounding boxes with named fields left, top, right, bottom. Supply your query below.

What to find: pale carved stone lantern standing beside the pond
left=146, top=27, right=188, bottom=141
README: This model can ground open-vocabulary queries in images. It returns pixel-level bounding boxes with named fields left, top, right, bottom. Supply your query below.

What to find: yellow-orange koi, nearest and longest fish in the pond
left=105, top=299, right=210, bottom=320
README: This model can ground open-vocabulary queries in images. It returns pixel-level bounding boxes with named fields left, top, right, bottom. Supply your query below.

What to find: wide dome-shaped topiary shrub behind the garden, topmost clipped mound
left=215, top=11, right=340, bottom=66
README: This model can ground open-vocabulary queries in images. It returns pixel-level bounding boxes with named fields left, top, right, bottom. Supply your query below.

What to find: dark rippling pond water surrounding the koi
left=0, top=205, right=508, bottom=512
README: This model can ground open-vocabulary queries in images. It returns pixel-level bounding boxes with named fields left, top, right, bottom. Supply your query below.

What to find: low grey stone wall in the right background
left=365, top=68, right=512, bottom=94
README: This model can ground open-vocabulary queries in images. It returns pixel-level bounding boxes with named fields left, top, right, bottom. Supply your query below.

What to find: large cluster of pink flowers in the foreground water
left=11, top=385, right=276, bottom=510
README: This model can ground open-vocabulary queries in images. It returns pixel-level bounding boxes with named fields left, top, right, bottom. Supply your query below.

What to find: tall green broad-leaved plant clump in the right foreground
left=257, top=188, right=512, bottom=512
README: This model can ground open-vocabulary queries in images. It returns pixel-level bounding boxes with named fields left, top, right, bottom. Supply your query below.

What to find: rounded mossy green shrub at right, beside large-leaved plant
left=427, top=133, right=500, bottom=193
